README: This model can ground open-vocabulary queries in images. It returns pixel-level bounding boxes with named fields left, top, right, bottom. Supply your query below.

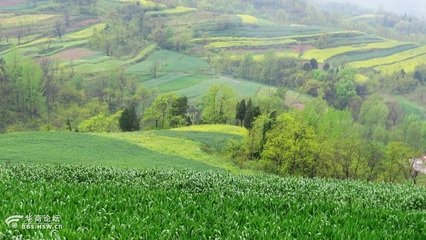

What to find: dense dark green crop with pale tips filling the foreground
left=0, top=165, right=426, bottom=239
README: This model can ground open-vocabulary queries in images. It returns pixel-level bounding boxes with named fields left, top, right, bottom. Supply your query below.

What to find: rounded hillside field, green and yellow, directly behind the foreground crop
left=0, top=125, right=253, bottom=173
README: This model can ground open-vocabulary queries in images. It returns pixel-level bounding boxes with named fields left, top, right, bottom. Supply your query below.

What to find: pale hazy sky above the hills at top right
left=309, top=0, right=426, bottom=17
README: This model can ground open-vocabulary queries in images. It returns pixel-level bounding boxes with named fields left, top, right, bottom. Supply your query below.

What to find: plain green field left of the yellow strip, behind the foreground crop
left=0, top=132, right=215, bottom=170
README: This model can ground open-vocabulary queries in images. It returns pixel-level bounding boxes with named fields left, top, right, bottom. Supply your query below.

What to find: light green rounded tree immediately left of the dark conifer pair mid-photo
left=202, top=85, right=236, bottom=124
